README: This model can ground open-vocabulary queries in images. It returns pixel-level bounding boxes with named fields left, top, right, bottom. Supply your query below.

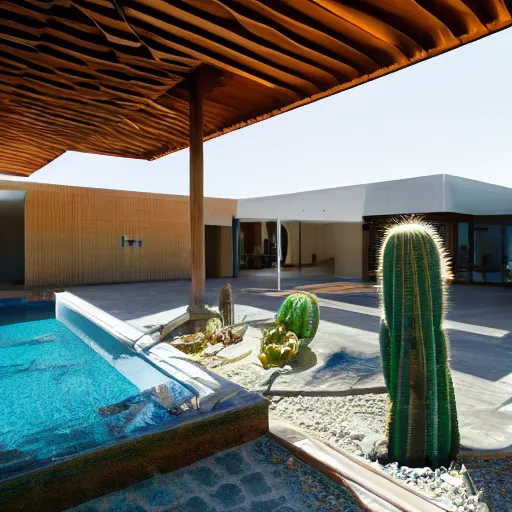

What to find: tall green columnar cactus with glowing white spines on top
left=379, top=221, right=459, bottom=468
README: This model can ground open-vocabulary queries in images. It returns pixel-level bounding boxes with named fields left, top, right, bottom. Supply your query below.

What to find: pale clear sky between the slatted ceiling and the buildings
left=12, top=29, right=512, bottom=198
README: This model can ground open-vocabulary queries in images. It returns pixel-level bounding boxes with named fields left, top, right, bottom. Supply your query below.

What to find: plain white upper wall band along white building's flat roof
left=237, top=174, right=512, bottom=222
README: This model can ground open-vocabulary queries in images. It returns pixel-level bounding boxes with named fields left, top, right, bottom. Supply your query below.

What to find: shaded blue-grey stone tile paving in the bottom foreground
left=69, top=437, right=362, bottom=512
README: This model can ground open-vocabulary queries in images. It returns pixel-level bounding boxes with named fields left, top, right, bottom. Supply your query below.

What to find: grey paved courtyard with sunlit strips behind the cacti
left=68, top=271, right=512, bottom=450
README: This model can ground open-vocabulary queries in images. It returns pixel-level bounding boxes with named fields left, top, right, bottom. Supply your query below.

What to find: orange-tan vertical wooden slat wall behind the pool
left=0, top=181, right=236, bottom=286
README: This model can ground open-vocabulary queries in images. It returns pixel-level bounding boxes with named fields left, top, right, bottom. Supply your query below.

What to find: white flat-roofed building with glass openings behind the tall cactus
left=237, top=174, right=512, bottom=283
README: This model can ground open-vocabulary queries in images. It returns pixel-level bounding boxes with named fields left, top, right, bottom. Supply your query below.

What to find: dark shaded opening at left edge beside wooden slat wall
left=0, top=201, right=25, bottom=282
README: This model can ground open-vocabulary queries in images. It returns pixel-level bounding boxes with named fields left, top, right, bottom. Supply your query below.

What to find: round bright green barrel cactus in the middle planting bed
left=276, top=292, right=320, bottom=348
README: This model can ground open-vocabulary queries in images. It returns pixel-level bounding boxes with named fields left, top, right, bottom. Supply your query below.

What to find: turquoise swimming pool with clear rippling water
left=0, top=300, right=194, bottom=480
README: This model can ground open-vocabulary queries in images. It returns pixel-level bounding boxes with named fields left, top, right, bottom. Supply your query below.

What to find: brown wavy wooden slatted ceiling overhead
left=0, top=0, right=512, bottom=176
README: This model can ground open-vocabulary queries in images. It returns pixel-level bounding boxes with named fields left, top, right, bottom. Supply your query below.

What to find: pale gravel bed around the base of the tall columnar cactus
left=270, top=395, right=506, bottom=512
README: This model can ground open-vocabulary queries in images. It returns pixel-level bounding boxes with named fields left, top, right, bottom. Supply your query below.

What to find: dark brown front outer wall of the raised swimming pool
left=0, top=397, right=269, bottom=512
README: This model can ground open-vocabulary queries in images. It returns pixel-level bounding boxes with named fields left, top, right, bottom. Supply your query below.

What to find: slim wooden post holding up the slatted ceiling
left=189, top=70, right=205, bottom=313
